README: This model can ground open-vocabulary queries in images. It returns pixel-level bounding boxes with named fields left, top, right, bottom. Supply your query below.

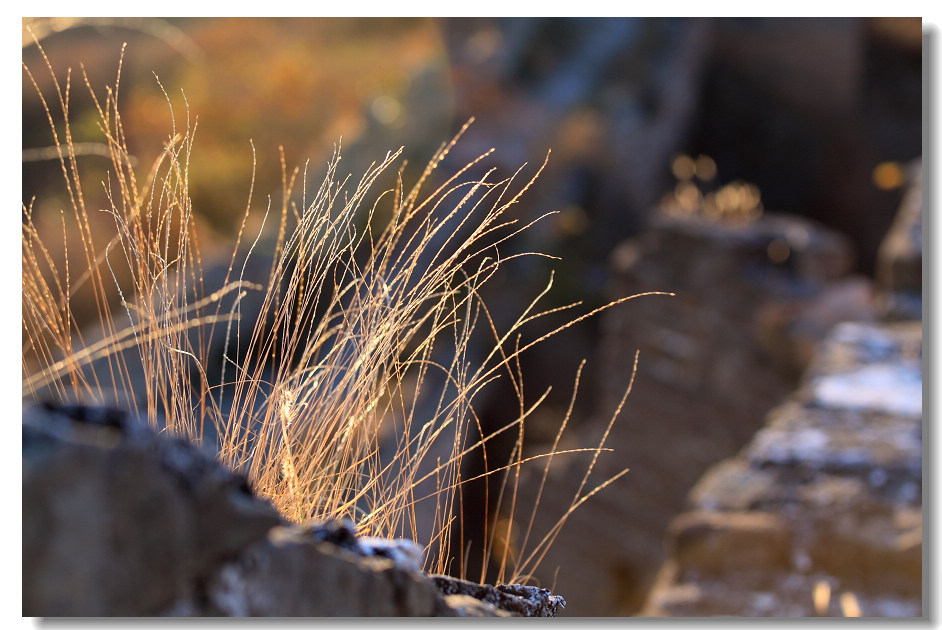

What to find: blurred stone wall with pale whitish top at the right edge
left=642, top=321, right=922, bottom=617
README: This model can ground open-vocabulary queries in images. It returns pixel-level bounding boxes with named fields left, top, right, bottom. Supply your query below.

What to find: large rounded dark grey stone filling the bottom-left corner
left=23, top=405, right=279, bottom=616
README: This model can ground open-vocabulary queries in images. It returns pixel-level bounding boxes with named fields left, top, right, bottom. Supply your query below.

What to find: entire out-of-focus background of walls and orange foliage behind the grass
left=22, top=18, right=923, bottom=616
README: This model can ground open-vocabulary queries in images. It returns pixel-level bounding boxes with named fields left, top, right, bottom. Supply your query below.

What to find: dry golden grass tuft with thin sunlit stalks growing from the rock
left=22, top=43, right=672, bottom=582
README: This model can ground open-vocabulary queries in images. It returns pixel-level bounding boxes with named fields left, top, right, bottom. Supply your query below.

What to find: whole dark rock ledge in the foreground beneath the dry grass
left=23, top=404, right=565, bottom=617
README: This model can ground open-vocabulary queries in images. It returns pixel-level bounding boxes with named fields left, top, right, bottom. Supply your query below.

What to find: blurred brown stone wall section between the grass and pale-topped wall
left=508, top=213, right=873, bottom=615
